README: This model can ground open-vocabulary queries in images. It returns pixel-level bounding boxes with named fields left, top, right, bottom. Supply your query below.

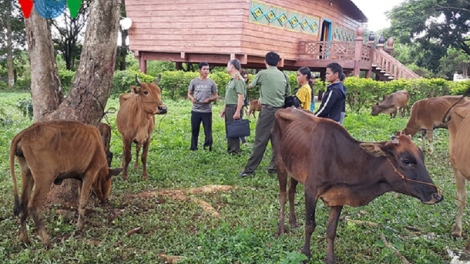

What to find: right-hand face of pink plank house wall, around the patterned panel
left=242, top=0, right=360, bottom=60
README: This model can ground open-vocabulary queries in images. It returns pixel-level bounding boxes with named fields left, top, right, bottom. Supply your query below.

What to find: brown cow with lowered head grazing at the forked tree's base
left=10, top=120, right=122, bottom=246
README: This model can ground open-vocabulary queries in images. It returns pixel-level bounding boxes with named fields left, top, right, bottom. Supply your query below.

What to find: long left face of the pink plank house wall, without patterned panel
left=126, top=0, right=249, bottom=54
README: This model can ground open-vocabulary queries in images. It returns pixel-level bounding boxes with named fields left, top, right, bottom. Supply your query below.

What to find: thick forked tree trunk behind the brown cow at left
left=26, top=0, right=120, bottom=206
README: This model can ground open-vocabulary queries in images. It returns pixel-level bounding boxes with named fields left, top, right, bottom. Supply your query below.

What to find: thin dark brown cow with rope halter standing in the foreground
left=271, top=108, right=443, bottom=263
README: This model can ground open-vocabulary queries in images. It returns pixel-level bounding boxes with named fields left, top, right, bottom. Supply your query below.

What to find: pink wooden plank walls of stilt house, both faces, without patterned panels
left=126, top=0, right=360, bottom=60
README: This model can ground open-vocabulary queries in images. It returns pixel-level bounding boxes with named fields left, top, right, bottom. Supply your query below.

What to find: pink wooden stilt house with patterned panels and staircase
left=126, top=0, right=418, bottom=80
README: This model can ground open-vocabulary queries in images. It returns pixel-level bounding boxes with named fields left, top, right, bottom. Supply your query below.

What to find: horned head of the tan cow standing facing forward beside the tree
left=132, top=75, right=167, bottom=115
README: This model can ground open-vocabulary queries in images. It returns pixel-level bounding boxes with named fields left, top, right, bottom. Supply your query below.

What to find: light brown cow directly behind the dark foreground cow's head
left=397, top=95, right=467, bottom=153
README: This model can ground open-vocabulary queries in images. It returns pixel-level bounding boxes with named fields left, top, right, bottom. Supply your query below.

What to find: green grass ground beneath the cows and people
left=0, top=93, right=469, bottom=264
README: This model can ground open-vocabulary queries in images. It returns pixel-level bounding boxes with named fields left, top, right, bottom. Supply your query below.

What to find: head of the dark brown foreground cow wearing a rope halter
left=360, top=135, right=443, bottom=204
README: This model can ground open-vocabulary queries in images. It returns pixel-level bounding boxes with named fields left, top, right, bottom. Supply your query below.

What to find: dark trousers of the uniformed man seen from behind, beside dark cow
left=244, top=105, right=281, bottom=173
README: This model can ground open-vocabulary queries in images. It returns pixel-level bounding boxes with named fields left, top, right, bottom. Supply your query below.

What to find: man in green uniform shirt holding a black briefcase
left=220, top=59, right=246, bottom=155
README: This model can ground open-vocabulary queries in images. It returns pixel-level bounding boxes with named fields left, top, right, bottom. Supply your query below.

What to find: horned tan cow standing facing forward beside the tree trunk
left=116, top=76, right=167, bottom=180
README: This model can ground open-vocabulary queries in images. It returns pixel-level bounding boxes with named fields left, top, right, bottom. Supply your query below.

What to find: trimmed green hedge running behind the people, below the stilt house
left=30, top=70, right=470, bottom=112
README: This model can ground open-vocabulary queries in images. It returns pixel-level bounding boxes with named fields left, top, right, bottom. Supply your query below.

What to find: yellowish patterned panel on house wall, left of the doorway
left=250, top=0, right=320, bottom=35
